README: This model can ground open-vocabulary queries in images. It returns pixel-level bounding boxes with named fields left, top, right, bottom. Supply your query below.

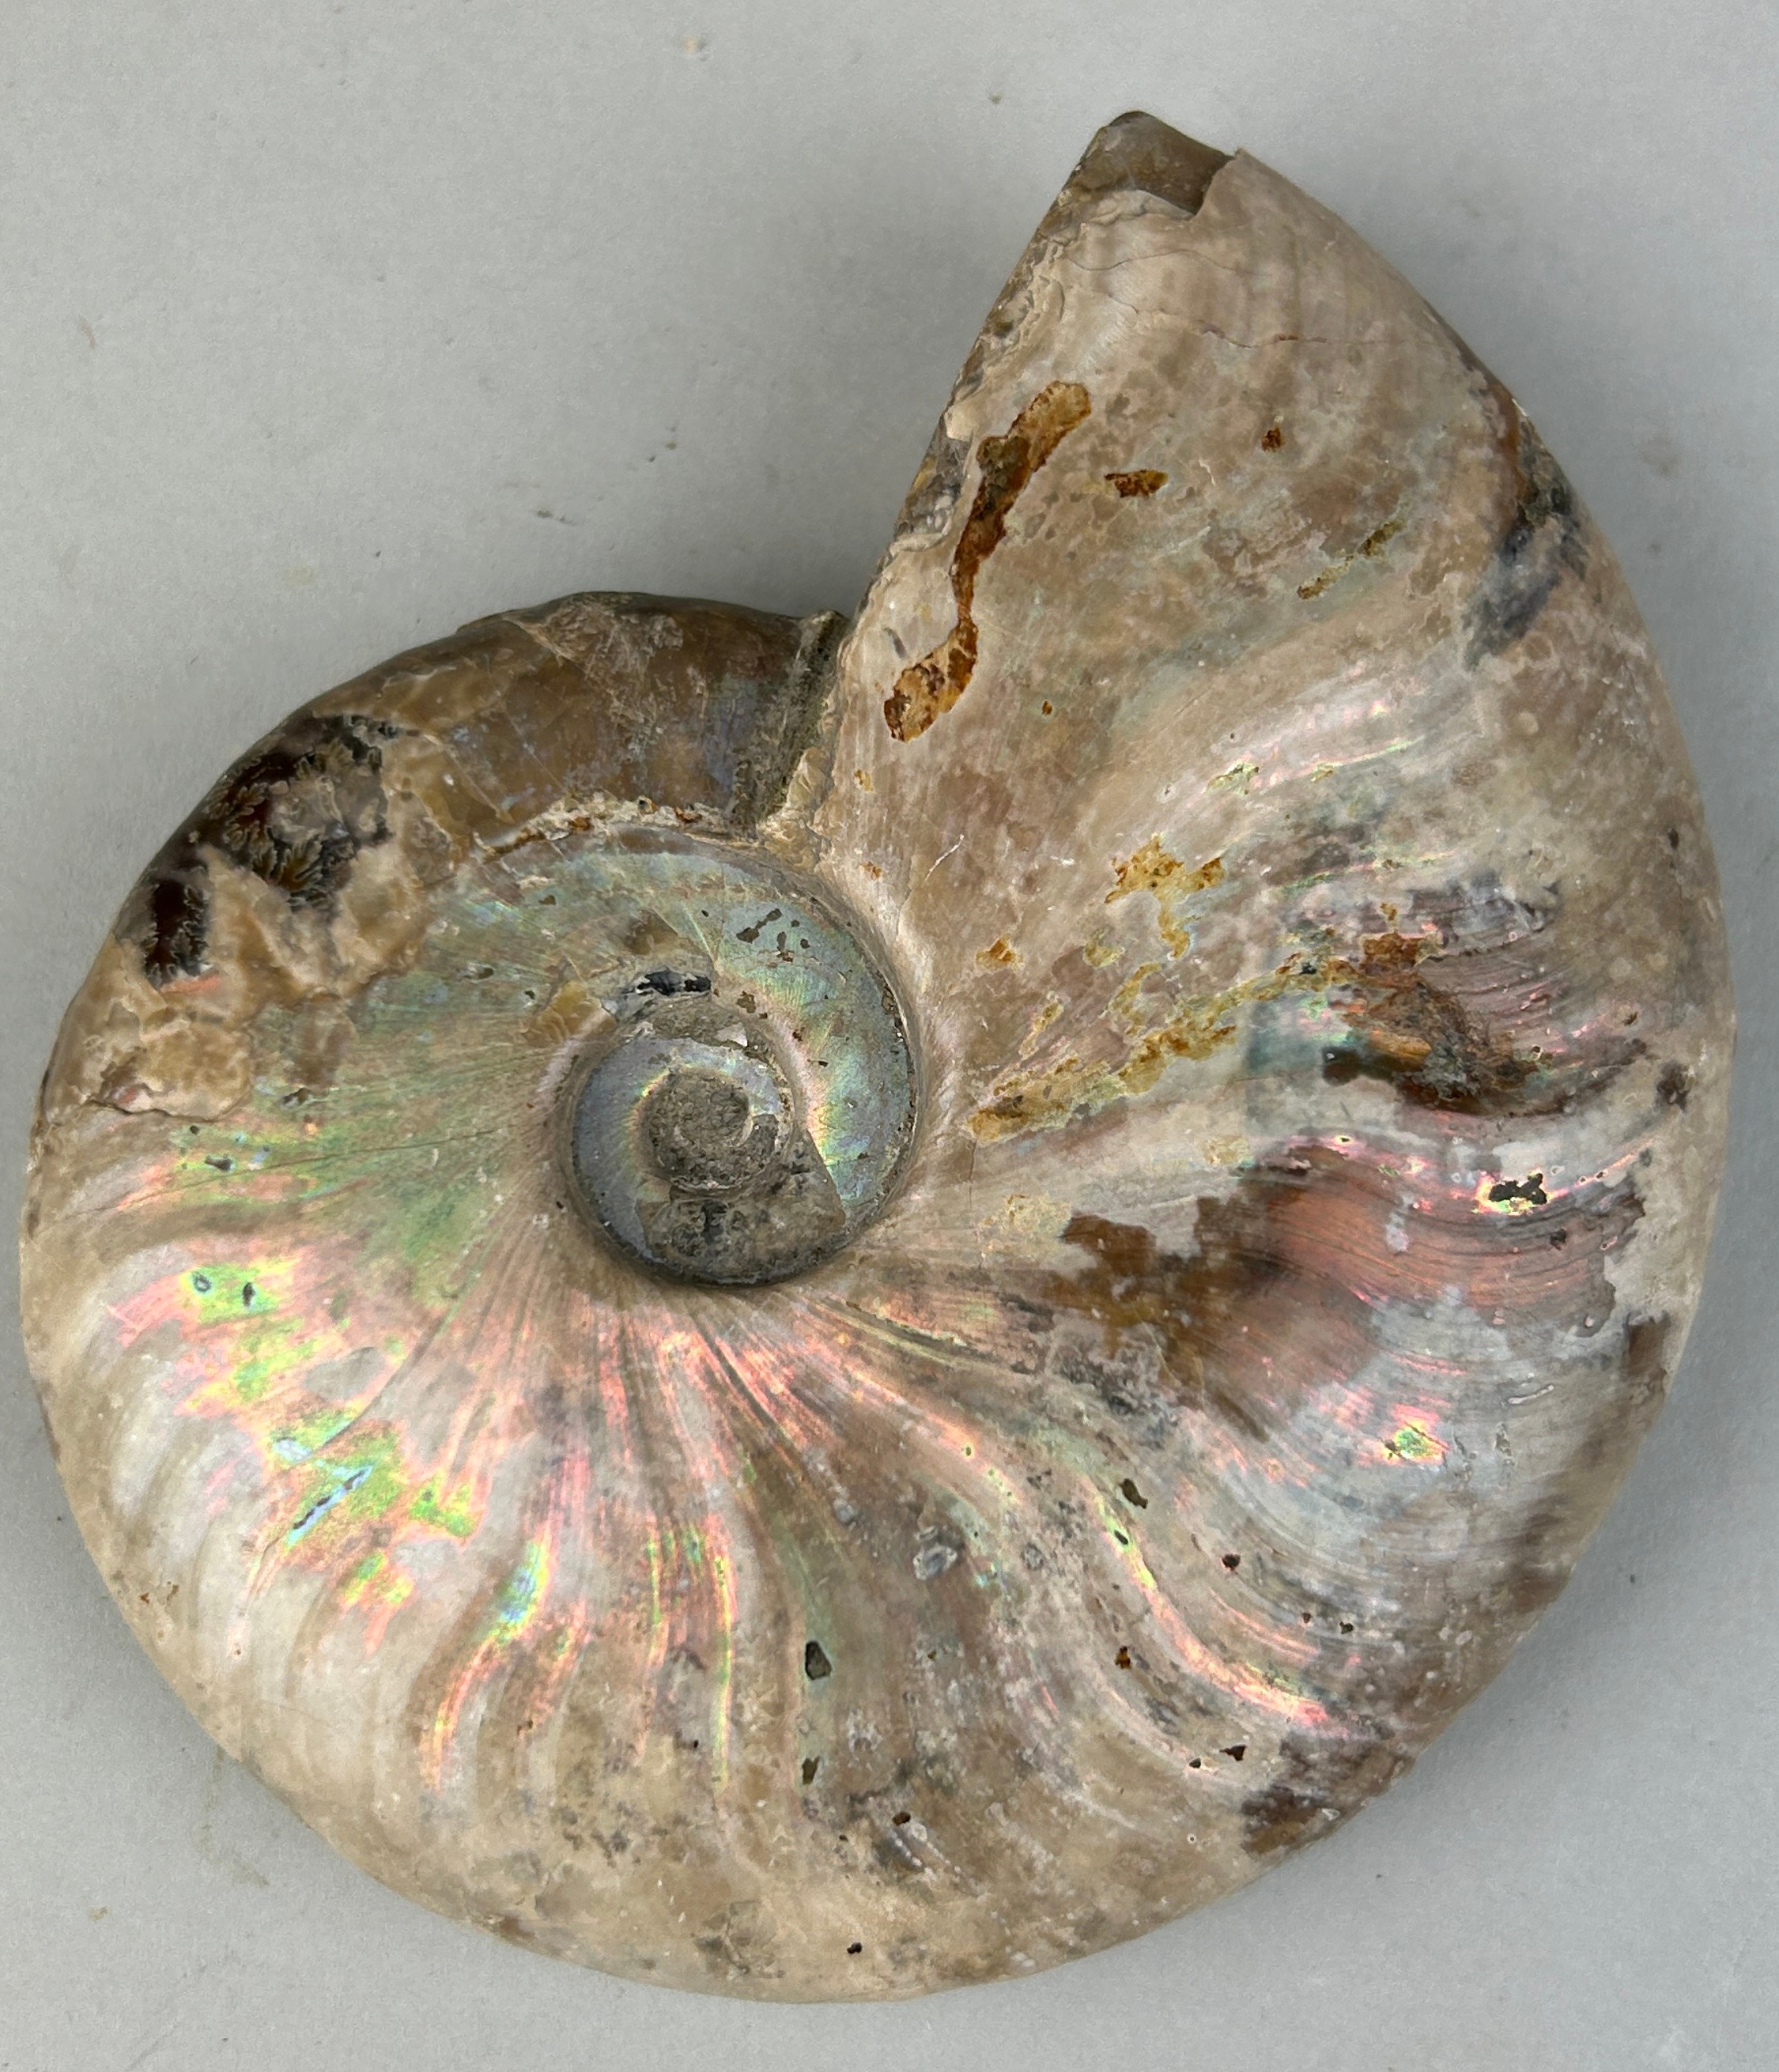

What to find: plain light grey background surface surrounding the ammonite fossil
left=0, top=0, right=1779, bottom=2072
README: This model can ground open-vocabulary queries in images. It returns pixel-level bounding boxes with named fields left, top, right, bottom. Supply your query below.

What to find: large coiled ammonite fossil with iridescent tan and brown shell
left=25, top=116, right=1732, bottom=1998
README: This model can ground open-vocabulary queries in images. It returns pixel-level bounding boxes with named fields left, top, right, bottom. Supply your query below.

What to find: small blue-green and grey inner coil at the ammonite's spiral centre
left=568, top=841, right=914, bottom=1285
